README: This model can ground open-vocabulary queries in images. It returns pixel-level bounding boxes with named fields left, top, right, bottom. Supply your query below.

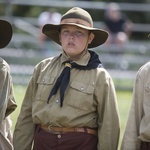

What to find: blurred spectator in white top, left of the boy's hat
left=38, top=8, right=61, bottom=55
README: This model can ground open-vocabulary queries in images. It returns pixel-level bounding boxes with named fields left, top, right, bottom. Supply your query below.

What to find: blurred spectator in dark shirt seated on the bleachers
left=104, top=2, right=132, bottom=46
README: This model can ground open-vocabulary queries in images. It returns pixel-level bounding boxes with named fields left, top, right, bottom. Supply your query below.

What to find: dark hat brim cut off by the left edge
left=0, top=19, right=12, bottom=48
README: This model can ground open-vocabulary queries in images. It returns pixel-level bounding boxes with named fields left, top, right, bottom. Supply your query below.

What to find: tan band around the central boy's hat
left=60, top=18, right=92, bottom=27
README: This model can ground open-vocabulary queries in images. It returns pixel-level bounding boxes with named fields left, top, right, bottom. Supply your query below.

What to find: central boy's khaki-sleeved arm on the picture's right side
left=97, top=69, right=120, bottom=150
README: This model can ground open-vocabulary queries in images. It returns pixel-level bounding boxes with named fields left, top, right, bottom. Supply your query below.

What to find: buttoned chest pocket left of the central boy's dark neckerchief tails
left=36, top=76, right=55, bottom=101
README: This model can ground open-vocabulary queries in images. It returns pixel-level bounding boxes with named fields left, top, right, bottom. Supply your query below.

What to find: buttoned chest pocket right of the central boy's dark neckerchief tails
left=66, top=81, right=94, bottom=111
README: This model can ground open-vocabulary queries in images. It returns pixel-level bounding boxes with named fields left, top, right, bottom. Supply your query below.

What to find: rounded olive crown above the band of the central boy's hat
left=61, top=7, right=93, bottom=27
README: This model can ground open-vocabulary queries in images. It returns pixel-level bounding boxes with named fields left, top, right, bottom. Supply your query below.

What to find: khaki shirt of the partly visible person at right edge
left=122, top=62, right=150, bottom=150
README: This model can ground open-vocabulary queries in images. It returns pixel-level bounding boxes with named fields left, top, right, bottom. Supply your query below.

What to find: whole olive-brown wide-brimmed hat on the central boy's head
left=42, top=7, right=108, bottom=48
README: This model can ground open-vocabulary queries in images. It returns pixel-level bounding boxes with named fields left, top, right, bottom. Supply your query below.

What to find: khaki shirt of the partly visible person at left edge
left=0, top=58, right=17, bottom=150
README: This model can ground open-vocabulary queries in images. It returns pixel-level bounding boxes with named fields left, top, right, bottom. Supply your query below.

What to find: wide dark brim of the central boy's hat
left=42, top=23, right=108, bottom=48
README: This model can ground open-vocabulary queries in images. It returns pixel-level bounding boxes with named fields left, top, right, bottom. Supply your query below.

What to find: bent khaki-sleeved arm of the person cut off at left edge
left=0, top=60, right=17, bottom=122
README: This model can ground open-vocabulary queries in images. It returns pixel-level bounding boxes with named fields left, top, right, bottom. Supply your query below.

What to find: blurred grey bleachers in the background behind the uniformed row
left=0, top=0, right=150, bottom=90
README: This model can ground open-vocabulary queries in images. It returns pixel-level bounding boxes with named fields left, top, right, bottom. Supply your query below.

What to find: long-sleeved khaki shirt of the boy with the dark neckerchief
left=14, top=53, right=120, bottom=150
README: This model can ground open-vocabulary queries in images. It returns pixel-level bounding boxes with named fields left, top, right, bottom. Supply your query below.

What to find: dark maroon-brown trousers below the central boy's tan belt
left=33, top=127, right=98, bottom=150
